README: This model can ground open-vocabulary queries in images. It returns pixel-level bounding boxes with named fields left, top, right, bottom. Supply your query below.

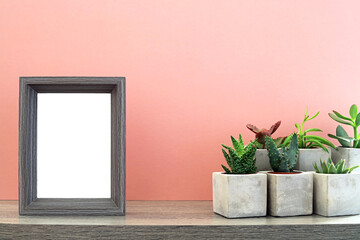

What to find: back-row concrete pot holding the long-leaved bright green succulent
left=294, top=147, right=332, bottom=171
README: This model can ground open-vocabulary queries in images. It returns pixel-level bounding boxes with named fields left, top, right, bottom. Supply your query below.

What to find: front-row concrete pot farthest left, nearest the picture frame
left=213, top=172, right=267, bottom=218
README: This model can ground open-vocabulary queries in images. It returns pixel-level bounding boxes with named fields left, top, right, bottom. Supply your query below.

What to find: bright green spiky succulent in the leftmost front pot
left=221, top=134, right=257, bottom=174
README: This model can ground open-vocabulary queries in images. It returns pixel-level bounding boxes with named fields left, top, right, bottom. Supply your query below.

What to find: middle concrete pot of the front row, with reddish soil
left=267, top=172, right=313, bottom=217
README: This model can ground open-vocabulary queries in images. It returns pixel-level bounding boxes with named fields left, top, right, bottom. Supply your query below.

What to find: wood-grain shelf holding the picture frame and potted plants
left=0, top=201, right=360, bottom=239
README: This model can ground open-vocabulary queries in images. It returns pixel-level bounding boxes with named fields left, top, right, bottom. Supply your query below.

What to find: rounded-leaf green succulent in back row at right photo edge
left=328, top=104, right=360, bottom=148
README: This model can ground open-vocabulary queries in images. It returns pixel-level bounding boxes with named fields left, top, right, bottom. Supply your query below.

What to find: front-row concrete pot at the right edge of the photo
left=314, top=173, right=360, bottom=216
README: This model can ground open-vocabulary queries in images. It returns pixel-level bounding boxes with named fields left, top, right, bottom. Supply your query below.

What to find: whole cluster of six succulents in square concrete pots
left=213, top=105, right=360, bottom=218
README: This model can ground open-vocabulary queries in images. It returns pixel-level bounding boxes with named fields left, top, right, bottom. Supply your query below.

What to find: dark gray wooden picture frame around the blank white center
left=19, top=77, right=126, bottom=215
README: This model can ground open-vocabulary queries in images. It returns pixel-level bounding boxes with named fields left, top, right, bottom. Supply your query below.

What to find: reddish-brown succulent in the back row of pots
left=246, top=121, right=285, bottom=149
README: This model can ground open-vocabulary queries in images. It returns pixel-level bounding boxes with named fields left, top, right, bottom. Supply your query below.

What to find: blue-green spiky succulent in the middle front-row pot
left=265, top=133, right=299, bottom=172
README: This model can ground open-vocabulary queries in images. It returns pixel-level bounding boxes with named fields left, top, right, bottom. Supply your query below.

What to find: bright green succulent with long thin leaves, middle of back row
left=283, top=106, right=336, bottom=152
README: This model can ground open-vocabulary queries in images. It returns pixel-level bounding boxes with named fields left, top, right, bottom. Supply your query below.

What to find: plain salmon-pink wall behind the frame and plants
left=0, top=0, right=360, bottom=200
